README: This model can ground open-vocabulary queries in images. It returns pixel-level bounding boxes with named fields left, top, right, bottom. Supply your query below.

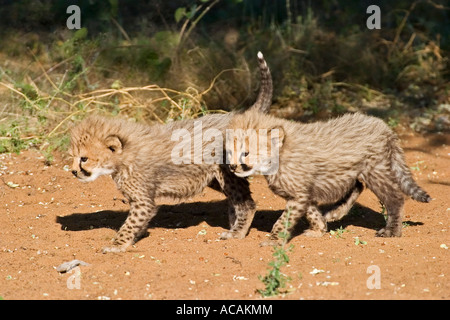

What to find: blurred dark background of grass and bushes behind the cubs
left=0, top=0, right=450, bottom=152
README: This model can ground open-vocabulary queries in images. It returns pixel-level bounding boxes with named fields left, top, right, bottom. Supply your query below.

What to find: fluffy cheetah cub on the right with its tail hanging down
left=226, top=110, right=431, bottom=245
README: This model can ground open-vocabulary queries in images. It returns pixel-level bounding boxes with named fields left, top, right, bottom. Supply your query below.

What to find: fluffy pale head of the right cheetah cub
left=226, top=120, right=284, bottom=177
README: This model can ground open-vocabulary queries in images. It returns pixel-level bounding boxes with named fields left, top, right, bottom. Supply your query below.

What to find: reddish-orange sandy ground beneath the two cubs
left=0, top=129, right=450, bottom=299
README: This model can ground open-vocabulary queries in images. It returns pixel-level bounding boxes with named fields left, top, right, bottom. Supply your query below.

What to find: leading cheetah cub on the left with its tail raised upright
left=70, top=53, right=272, bottom=252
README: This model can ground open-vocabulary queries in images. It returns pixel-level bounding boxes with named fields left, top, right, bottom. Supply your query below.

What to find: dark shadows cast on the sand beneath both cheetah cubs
left=56, top=200, right=423, bottom=241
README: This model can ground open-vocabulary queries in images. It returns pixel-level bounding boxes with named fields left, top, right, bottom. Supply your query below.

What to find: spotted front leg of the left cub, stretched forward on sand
left=102, top=198, right=157, bottom=253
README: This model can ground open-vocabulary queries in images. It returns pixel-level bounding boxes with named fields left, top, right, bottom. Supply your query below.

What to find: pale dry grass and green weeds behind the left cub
left=0, top=54, right=239, bottom=152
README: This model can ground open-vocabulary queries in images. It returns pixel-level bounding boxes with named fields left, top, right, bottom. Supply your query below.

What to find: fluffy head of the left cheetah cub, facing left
left=69, top=117, right=122, bottom=182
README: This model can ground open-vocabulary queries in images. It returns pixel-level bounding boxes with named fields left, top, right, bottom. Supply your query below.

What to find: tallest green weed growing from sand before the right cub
left=257, top=211, right=294, bottom=297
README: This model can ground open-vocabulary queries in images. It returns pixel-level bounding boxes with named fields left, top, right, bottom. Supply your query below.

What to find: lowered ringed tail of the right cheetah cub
left=390, top=137, right=431, bottom=202
